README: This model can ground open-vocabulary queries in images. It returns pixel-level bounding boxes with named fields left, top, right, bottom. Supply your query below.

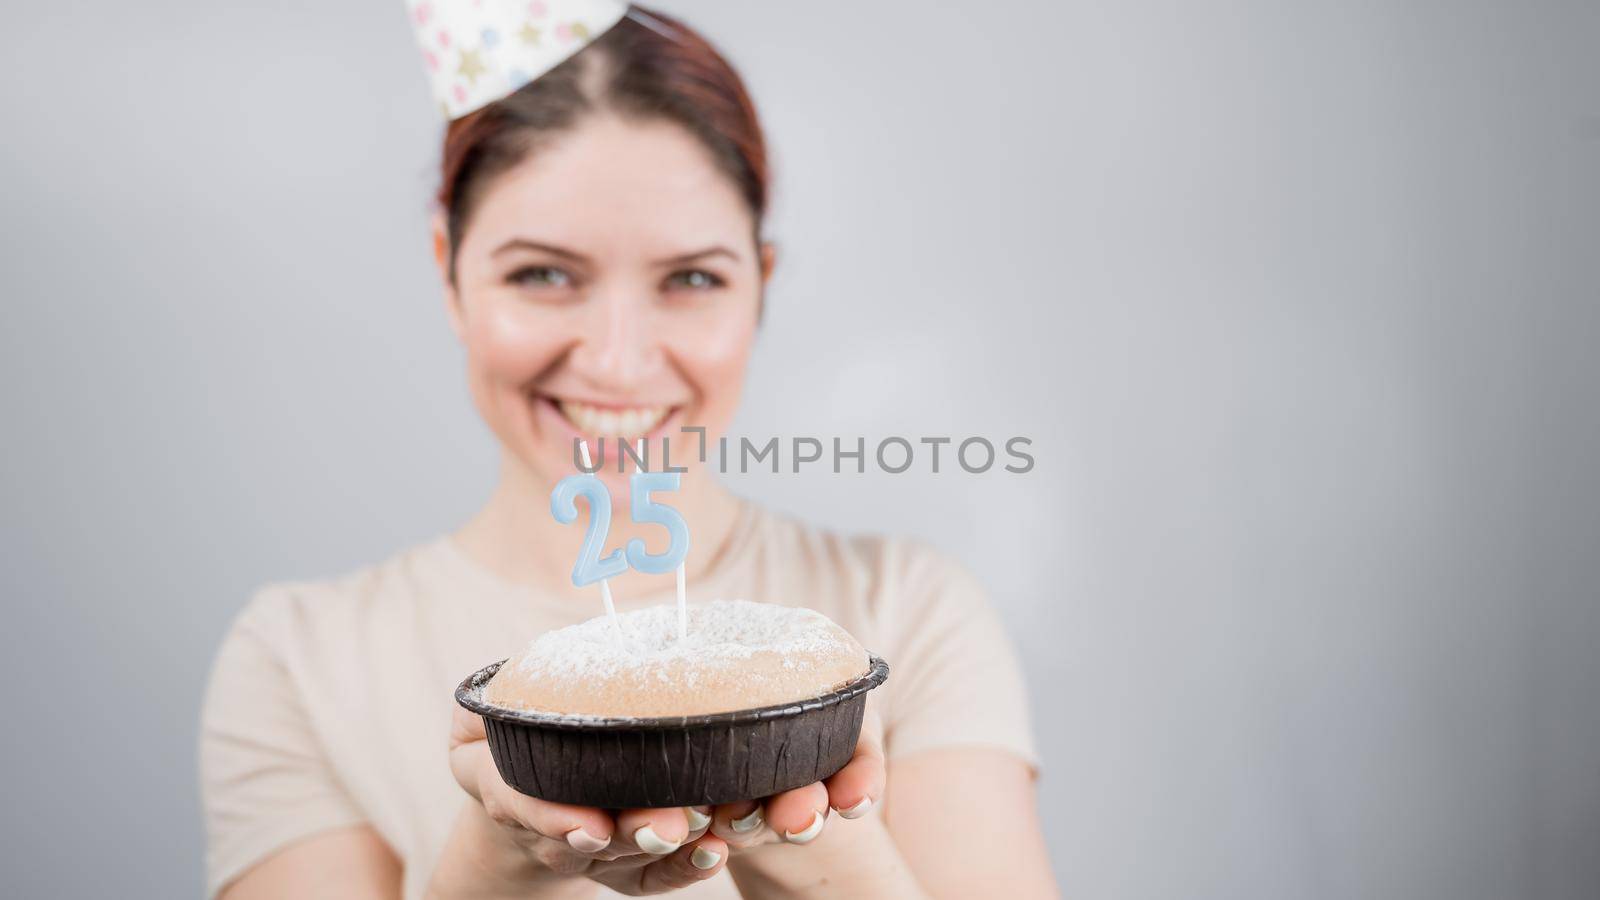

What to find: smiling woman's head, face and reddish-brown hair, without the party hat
left=435, top=14, right=773, bottom=515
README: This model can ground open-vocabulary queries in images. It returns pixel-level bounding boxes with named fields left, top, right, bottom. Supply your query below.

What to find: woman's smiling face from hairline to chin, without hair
left=435, top=114, right=771, bottom=503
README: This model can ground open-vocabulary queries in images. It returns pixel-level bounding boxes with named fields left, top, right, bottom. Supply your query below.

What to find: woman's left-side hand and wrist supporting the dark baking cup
left=429, top=708, right=728, bottom=898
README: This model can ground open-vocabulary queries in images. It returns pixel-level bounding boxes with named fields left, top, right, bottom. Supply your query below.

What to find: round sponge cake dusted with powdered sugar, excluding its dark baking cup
left=483, top=601, right=870, bottom=717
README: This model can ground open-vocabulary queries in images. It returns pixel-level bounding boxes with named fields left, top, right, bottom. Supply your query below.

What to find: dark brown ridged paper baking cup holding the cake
left=456, top=657, right=890, bottom=809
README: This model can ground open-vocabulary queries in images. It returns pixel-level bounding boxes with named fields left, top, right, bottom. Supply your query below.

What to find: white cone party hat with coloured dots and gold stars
left=406, top=0, right=627, bottom=119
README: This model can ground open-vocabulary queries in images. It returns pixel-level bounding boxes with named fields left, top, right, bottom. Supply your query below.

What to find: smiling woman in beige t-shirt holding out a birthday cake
left=202, top=8, right=1054, bottom=900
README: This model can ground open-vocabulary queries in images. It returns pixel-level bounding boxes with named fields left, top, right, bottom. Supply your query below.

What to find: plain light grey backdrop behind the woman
left=0, top=0, right=1600, bottom=898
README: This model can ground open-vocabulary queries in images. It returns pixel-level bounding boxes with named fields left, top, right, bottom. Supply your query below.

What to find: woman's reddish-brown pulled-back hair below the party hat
left=437, top=6, right=768, bottom=279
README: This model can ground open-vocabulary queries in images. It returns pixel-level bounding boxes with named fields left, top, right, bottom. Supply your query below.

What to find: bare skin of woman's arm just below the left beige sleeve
left=218, top=825, right=400, bottom=900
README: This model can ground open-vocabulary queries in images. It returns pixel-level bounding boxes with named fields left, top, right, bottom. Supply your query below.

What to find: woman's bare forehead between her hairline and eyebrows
left=462, top=114, right=754, bottom=253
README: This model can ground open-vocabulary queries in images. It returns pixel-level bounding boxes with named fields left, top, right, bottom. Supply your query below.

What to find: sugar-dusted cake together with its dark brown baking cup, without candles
left=456, top=601, right=890, bottom=809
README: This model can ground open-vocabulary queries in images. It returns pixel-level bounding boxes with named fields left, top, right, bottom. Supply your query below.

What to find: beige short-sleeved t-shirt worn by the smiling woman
left=200, top=504, right=1037, bottom=898
